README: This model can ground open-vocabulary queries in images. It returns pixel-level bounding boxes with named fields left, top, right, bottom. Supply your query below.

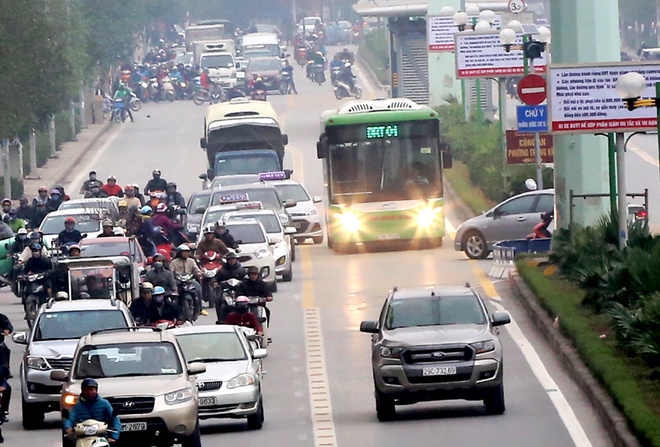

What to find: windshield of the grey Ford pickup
left=385, top=295, right=486, bottom=329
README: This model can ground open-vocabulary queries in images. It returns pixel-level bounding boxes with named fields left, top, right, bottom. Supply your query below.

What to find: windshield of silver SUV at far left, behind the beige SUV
left=33, top=309, right=128, bottom=341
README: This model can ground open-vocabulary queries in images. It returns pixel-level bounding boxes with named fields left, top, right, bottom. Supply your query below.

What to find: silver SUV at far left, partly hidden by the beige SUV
left=12, top=299, right=135, bottom=429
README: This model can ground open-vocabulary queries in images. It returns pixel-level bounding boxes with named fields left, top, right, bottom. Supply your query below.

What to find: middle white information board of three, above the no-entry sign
left=454, top=32, right=547, bottom=78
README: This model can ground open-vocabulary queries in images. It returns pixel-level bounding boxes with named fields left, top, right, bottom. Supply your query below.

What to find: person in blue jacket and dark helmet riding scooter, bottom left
left=64, top=379, right=121, bottom=442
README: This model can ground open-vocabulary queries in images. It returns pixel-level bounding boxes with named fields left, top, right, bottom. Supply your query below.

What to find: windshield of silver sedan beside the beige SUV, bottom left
left=176, top=332, right=247, bottom=363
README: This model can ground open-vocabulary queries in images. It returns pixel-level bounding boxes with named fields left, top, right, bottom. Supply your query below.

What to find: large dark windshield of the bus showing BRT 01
left=326, top=120, right=442, bottom=204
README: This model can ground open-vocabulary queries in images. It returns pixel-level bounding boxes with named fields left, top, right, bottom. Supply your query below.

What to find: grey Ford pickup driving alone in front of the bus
left=360, top=284, right=511, bottom=421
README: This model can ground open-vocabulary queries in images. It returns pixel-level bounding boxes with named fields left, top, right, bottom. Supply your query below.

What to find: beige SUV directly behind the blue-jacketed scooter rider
left=50, top=327, right=206, bottom=447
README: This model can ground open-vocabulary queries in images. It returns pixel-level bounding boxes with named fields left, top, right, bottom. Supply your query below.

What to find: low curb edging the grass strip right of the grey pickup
left=509, top=273, right=642, bottom=447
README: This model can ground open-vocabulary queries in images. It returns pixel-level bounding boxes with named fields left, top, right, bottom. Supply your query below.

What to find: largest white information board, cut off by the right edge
left=548, top=62, right=660, bottom=134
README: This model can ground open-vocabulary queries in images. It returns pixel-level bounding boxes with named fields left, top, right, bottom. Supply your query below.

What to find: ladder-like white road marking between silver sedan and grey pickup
left=305, top=307, right=337, bottom=447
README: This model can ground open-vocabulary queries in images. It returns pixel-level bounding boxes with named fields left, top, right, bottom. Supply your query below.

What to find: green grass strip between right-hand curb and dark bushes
left=516, top=260, right=660, bottom=447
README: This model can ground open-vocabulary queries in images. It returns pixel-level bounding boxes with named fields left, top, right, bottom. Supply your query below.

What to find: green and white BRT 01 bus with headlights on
left=316, top=98, right=452, bottom=252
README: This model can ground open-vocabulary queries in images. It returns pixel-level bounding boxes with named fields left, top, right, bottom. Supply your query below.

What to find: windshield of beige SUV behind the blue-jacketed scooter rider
left=73, top=342, right=183, bottom=379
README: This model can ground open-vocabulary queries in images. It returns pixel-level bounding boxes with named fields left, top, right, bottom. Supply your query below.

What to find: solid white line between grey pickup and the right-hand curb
left=490, top=296, right=592, bottom=447
